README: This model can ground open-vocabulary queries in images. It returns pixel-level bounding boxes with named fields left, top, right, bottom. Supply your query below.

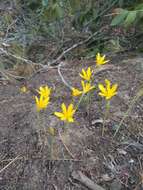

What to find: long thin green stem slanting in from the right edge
left=113, top=88, right=143, bottom=137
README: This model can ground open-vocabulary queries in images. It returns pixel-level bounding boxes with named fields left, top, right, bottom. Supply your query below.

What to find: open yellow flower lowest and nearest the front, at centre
left=54, top=103, right=76, bottom=122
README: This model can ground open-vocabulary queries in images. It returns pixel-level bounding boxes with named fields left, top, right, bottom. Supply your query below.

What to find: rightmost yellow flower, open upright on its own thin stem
left=98, top=79, right=118, bottom=100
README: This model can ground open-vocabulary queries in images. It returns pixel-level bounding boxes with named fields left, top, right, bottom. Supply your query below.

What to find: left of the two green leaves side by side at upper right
left=111, top=10, right=129, bottom=26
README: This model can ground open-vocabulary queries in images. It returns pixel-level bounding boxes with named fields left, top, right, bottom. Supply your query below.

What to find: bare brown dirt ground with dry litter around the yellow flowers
left=0, top=52, right=143, bottom=190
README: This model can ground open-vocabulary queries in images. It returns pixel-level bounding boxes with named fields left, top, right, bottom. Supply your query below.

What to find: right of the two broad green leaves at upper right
left=124, top=11, right=137, bottom=27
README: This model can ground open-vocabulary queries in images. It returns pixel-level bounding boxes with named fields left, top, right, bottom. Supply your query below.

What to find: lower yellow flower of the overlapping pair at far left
left=35, top=96, right=49, bottom=112
